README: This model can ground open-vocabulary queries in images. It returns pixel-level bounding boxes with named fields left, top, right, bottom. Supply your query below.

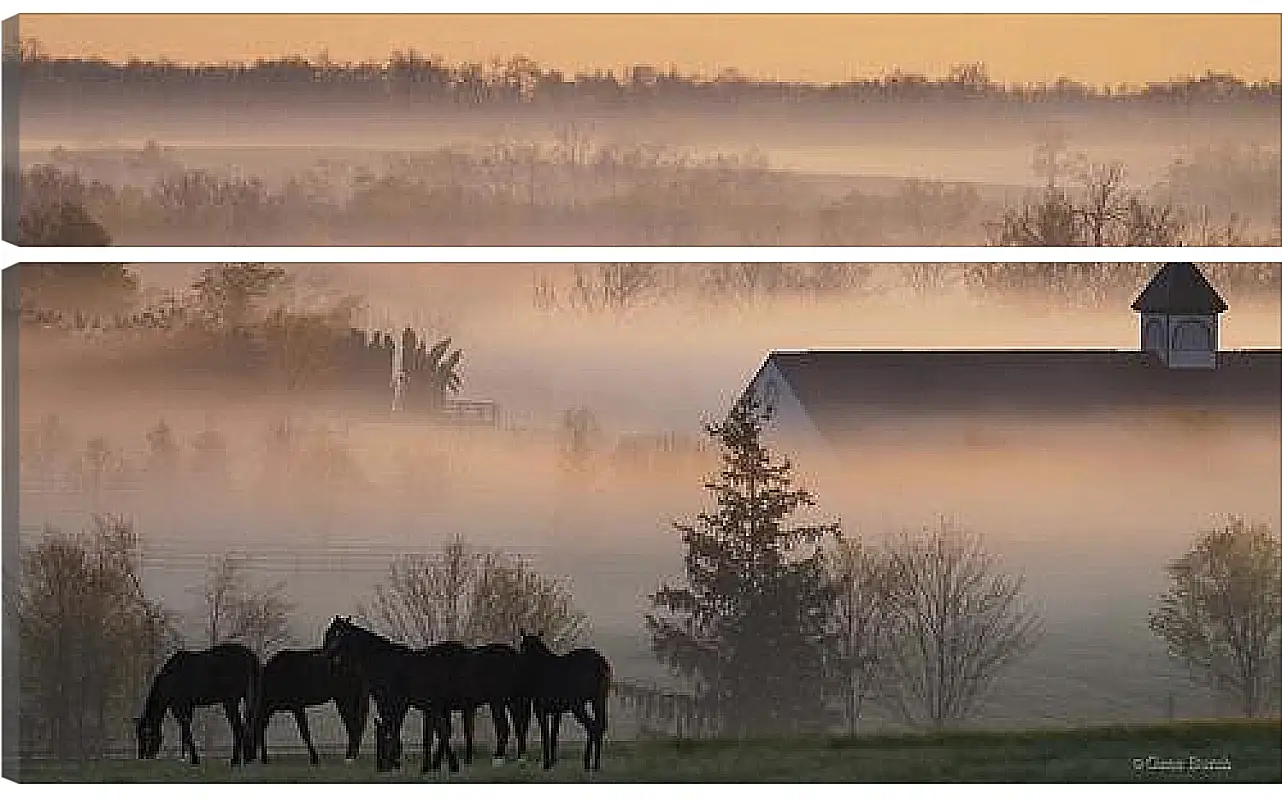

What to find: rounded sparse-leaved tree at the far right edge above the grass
left=1149, top=517, right=1282, bottom=717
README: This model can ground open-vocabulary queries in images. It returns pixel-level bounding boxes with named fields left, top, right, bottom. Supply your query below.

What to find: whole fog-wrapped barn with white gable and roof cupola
left=745, top=263, right=1282, bottom=445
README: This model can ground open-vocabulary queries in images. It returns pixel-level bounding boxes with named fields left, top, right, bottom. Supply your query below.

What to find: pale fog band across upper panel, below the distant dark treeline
left=12, top=97, right=1282, bottom=246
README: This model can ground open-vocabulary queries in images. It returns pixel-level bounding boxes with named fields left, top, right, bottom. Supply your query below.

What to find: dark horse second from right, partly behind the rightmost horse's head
left=450, top=644, right=531, bottom=764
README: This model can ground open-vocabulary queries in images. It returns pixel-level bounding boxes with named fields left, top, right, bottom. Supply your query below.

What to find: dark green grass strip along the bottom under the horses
left=6, top=719, right=1282, bottom=783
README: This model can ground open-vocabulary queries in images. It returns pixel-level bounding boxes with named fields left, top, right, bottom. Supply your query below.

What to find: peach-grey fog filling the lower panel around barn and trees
left=9, top=264, right=1282, bottom=724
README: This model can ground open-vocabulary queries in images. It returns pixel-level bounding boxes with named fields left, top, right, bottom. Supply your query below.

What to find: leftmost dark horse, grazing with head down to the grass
left=135, top=644, right=263, bottom=765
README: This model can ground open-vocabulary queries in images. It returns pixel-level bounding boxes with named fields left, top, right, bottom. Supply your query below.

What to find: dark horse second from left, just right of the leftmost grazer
left=254, top=650, right=369, bottom=764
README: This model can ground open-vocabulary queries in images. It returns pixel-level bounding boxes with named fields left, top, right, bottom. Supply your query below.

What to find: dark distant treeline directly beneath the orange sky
left=6, top=38, right=1282, bottom=106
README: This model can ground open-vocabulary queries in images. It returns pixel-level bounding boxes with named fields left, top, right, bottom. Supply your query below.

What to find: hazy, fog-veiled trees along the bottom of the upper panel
left=15, top=137, right=1282, bottom=246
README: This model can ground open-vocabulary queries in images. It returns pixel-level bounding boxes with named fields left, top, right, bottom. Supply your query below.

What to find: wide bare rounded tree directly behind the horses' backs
left=360, top=536, right=587, bottom=647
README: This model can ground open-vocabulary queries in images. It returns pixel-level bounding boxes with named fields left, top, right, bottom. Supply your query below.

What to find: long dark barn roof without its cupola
left=768, top=350, right=1282, bottom=436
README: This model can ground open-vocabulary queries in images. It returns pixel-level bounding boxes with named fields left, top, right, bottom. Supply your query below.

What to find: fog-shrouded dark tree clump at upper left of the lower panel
left=17, top=261, right=463, bottom=400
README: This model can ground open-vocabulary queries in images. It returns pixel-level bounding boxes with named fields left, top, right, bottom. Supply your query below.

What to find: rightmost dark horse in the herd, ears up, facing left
left=520, top=632, right=610, bottom=771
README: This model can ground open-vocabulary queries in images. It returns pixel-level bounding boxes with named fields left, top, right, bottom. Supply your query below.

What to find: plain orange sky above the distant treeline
left=21, top=14, right=1282, bottom=85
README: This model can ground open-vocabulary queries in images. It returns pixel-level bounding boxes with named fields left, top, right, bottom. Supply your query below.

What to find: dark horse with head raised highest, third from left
left=324, top=617, right=464, bottom=772
